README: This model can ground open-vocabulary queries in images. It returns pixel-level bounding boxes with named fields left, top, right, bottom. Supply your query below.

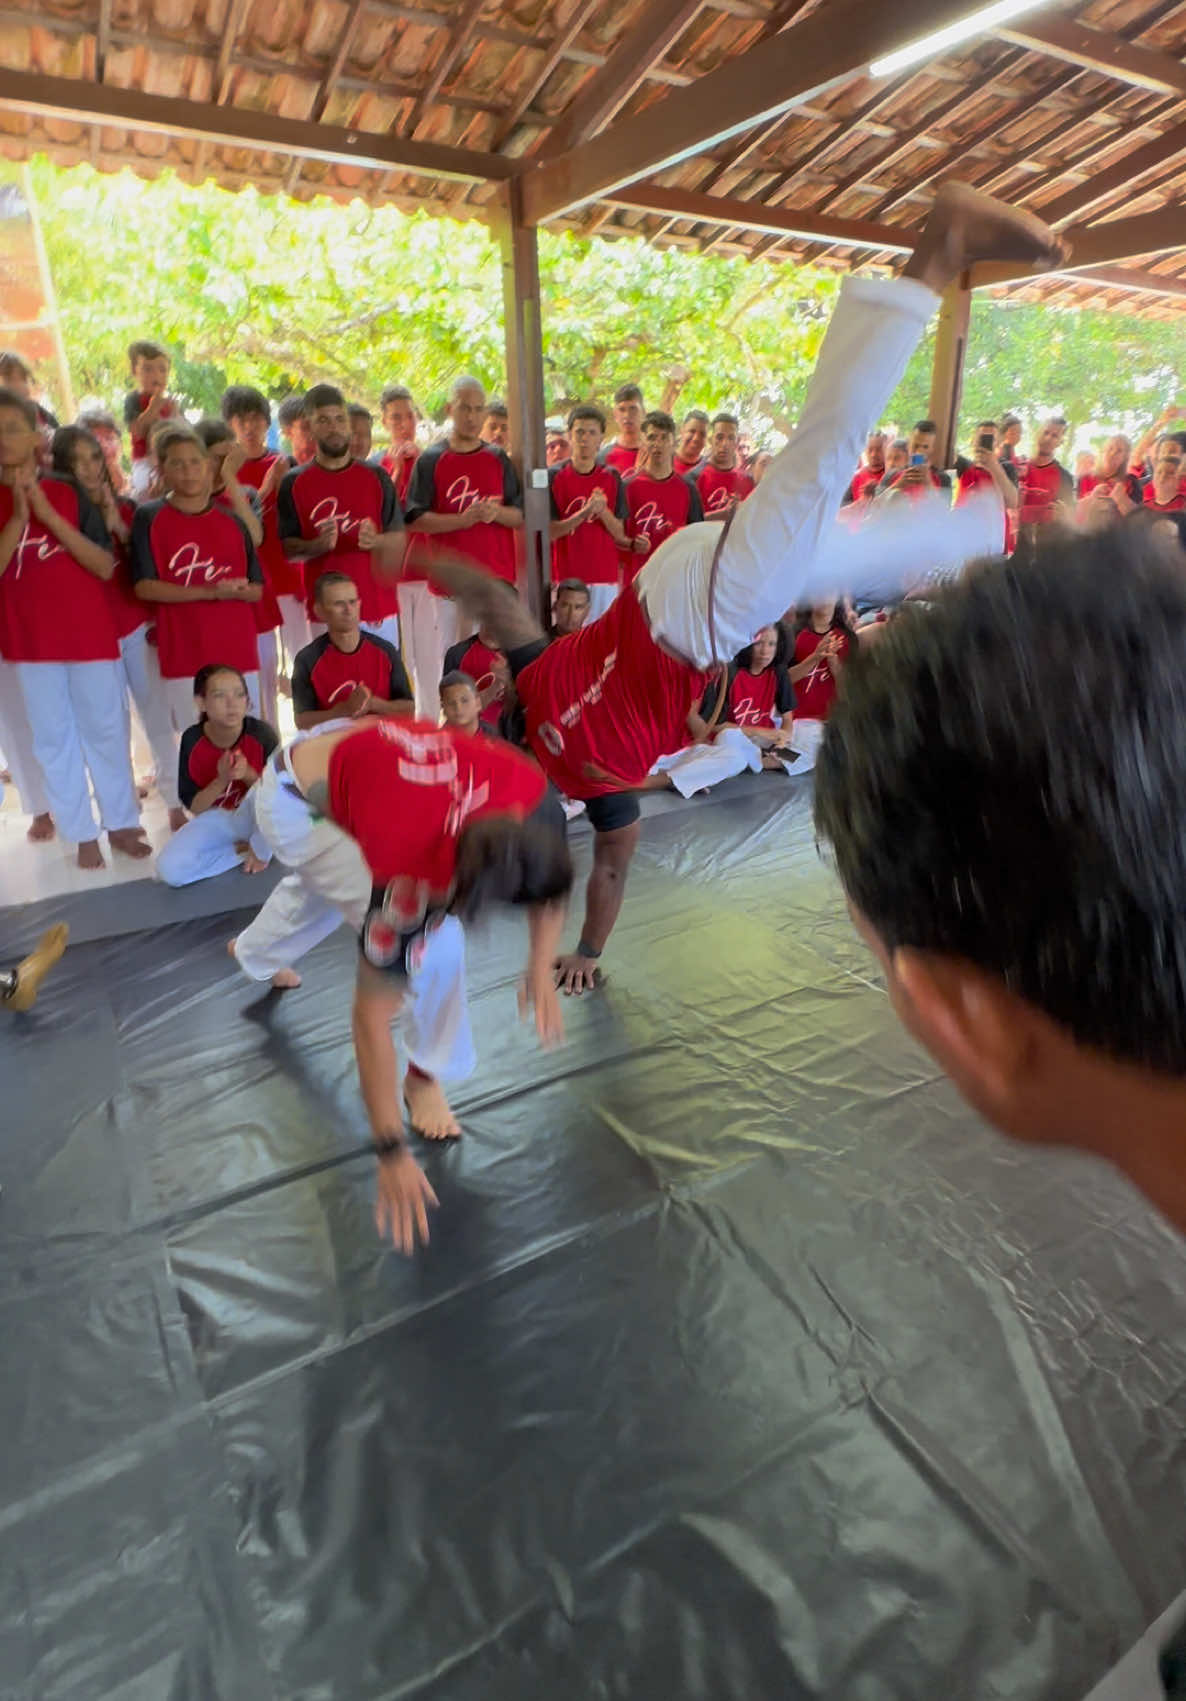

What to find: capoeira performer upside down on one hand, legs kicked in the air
left=432, top=184, right=1065, bottom=992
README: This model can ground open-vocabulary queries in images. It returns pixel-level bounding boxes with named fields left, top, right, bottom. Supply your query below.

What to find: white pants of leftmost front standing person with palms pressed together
left=15, top=662, right=140, bottom=844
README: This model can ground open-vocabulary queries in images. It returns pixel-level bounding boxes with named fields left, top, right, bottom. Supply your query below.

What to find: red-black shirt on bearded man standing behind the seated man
left=276, top=461, right=403, bottom=626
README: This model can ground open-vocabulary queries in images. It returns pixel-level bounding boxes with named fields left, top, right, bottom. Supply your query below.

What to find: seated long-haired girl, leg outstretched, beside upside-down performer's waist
left=652, top=626, right=795, bottom=798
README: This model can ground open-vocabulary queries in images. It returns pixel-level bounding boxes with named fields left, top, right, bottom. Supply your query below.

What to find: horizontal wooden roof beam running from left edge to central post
left=0, top=66, right=514, bottom=182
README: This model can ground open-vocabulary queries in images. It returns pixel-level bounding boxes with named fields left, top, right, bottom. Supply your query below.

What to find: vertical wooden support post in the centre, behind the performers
left=492, top=182, right=551, bottom=624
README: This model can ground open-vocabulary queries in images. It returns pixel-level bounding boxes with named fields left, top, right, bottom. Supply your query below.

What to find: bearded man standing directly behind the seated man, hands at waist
left=277, top=384, right=403, bottom=645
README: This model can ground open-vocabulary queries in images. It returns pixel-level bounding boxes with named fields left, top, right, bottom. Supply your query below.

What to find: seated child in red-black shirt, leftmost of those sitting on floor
left=157, top=663, right=279, bottom=886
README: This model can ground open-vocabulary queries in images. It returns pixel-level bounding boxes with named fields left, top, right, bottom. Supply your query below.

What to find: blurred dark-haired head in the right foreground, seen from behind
left=815, top=527, right=1186, bottom=1228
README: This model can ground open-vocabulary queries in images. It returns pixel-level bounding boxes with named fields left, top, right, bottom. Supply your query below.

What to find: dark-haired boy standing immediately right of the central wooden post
left=548, top=401, right=630, bottom=619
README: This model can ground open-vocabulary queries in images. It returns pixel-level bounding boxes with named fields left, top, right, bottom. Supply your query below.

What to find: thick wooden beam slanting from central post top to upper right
left=522, top=0, right=1007, bottom=223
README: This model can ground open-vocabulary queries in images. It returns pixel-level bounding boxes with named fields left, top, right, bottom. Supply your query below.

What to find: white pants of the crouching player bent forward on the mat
left=235, top=762, right=476, bottom=1080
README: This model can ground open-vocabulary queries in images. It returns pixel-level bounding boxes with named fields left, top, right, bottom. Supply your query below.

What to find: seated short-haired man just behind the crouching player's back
left=293, top=573, right=415, bottom=731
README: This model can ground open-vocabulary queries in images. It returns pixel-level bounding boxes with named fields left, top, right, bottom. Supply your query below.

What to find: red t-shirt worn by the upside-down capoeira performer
left=516, top=592, right=710, bottom=798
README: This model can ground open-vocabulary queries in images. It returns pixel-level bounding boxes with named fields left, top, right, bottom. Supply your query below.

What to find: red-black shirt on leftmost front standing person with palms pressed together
left=0, top=478, right=119, bottom=662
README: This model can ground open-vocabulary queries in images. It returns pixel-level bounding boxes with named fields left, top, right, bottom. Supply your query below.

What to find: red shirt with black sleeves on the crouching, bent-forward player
left=328, top=720, right=548, bottom=975
